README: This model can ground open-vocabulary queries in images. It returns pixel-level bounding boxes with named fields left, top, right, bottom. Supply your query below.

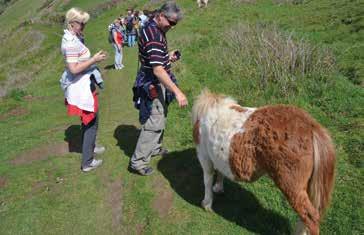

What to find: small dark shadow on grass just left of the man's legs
left=114, top=125, right=140, bottom=157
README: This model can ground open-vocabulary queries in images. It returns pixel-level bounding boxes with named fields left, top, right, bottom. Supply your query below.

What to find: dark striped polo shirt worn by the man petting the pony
left=138, top=19, right=171, bottom=73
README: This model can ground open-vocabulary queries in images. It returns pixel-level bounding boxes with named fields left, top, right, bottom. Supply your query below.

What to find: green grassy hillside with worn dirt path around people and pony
left=0, top=0, right=364, bottom=234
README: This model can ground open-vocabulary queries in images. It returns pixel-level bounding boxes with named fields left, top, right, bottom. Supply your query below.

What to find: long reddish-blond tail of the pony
left=308, top=127, right=335, bottom=218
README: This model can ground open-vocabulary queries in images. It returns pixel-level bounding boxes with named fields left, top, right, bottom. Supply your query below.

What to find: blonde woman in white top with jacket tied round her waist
left=61, top=8, right=106, bottom=172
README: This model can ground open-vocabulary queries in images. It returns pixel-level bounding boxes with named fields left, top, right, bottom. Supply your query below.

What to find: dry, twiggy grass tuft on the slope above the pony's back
left=213, top=24, right=335, bottom=94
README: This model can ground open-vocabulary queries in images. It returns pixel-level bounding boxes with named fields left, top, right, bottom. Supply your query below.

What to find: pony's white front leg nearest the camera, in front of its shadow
left=197, top=151, right=214, bottom=211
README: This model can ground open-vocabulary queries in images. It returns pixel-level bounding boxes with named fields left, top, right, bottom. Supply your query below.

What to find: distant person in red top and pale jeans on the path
left=109, top=18, right=124, bottom=70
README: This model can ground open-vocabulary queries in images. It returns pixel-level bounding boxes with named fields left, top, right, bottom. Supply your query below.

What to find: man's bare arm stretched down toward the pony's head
left=153, top=65, right=188, bottom=107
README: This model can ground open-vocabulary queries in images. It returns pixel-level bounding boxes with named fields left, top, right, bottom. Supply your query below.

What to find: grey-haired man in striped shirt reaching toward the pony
left=130, top=2, right=188, bottom=175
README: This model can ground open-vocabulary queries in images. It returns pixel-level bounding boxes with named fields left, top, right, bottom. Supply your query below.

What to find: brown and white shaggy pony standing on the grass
left=192, top=89, right=335, bottom=235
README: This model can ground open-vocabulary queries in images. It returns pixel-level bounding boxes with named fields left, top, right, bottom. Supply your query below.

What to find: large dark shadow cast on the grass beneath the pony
left=158, top=148, right=291, bottom=234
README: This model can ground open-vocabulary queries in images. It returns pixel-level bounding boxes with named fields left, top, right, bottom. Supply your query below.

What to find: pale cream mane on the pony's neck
left=192, top=88, right=236, bottom=124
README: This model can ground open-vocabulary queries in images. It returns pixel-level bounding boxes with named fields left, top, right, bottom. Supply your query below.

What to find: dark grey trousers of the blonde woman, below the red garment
left=81, top=114, right=99, bottom=167
